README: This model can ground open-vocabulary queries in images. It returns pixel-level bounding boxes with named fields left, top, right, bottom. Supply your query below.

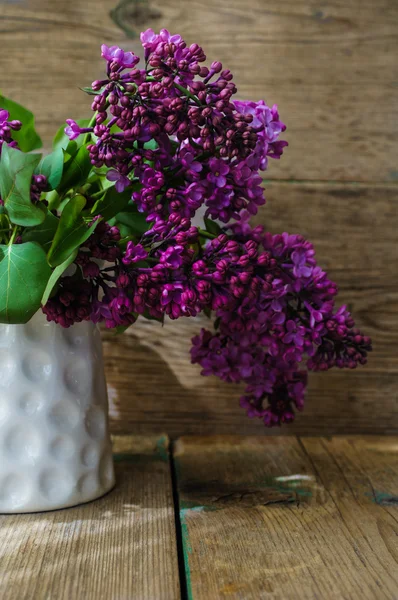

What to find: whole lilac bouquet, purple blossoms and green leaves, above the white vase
left=0, top=29, right=371, bottom=426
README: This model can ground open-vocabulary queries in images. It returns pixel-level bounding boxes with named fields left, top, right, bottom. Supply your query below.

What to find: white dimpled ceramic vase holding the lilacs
left=0, top=312, right=115, bottom=513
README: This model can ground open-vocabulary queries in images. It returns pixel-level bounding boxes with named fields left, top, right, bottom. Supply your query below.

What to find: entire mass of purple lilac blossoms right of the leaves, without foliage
left=43, top=30, right=371, bottom=426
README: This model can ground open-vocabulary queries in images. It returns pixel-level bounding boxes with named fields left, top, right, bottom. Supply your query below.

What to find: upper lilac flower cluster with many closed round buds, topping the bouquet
left=66, top=30, right=286, bottom=231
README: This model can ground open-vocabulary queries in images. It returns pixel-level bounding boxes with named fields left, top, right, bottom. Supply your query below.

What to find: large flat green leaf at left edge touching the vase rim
left=0, top=242, right=51, bottom=323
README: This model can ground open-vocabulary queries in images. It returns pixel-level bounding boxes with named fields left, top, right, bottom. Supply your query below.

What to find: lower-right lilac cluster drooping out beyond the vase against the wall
left=191, top=224, right=371, bottom=426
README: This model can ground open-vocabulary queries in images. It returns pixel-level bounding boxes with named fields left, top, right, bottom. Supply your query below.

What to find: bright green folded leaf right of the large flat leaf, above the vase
left=47, top=196, right=99, bottom=267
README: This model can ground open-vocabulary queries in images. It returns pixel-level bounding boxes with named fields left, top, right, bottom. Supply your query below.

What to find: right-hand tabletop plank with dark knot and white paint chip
left=174, top=437, right=398, bottom=600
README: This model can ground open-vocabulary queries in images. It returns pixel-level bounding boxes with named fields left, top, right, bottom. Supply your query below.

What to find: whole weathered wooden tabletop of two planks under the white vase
left=0, top=436, right=398, bottom=600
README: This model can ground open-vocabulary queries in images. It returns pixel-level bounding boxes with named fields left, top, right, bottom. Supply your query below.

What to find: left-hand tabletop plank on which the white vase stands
left=0, top=436, right=180, bottom=600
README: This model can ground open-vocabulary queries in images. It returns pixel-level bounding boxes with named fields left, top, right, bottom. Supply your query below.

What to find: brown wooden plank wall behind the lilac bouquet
left=0, top=0, right=398, bottom=435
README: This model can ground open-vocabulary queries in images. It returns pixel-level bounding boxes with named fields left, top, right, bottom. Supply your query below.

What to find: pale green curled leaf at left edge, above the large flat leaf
left=0, top=144, right=46, bottom=227
